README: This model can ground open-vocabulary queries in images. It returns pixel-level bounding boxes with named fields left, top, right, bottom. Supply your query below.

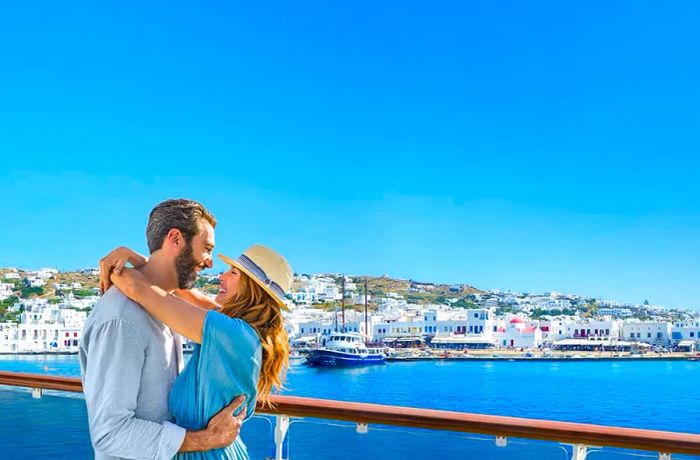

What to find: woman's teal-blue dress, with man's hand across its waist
left=170, top=310, right=262, bottom=460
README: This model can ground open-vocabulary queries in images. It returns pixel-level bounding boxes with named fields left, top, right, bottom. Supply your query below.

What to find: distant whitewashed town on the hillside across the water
left=0, top=268, right=700, bottom=353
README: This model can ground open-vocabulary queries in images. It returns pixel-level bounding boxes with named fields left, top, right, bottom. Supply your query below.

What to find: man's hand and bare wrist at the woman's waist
left=180, top=395, right=247, bottom=452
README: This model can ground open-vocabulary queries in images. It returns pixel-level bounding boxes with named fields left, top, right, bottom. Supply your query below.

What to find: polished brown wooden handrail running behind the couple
left=0, top=372, right=700, bottom=455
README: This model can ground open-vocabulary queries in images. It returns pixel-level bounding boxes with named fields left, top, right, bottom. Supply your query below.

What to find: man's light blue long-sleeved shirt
left=80, top=287, right=185, bottom=460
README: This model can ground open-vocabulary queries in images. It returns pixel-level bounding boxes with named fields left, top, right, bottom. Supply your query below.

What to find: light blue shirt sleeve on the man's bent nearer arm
left=83, top=320, right=186, bottom=460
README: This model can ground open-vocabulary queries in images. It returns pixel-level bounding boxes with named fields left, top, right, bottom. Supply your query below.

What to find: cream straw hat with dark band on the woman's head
left=219, top=244, right=292, bottom=311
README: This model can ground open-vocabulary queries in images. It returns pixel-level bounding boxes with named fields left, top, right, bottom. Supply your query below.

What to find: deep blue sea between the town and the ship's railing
left=0, top=355, right=700, bottom=460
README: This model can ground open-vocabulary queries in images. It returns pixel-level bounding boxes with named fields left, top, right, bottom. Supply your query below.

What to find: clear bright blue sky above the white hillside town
left=0, top=1, right=700, bottom=307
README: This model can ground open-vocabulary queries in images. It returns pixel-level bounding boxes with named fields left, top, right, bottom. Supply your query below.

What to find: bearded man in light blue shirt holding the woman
left=80, top=200, right=245, bottom=460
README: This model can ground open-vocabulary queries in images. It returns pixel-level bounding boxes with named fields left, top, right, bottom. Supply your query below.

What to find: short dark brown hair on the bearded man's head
left=146, top=199, right=216, bottom=254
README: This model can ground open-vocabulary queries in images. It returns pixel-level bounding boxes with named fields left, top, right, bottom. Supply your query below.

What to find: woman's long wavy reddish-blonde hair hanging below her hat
left=219, top=271, right=289, bottom=406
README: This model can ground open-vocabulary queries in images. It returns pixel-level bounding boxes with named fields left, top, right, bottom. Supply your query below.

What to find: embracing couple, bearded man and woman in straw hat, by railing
left=80, top=199, right=292, bottom=460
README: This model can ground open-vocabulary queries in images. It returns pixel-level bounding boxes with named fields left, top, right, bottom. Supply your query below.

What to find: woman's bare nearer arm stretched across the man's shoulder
left=111, top=268, right=208, bottom=343
